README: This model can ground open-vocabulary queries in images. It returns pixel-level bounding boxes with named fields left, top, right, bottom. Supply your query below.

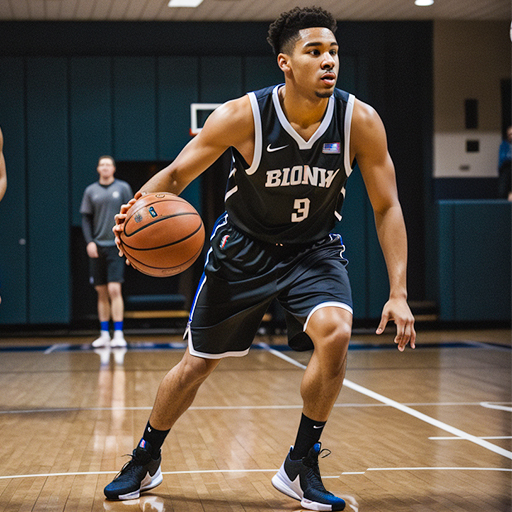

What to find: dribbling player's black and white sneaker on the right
left=272, top=443, right=345, bottom=511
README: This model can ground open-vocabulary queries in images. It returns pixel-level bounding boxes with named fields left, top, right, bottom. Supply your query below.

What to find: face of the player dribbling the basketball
left=289, top=27, right=339, bottom=98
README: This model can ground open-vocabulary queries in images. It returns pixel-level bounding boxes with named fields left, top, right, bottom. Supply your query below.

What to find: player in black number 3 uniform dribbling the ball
left=105, top=8, right=416, bottom=510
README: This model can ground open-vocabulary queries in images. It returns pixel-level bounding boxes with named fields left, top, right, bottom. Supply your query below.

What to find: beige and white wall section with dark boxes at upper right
left=433, top=20, right=511, bottom=199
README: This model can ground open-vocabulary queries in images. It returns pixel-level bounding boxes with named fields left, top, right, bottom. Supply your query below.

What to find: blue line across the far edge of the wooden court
left=0, top=341, right=506, bottom=353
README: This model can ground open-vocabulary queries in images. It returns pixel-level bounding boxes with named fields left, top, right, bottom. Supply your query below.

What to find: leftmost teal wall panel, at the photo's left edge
left=0, top=57, right=28, bottom=324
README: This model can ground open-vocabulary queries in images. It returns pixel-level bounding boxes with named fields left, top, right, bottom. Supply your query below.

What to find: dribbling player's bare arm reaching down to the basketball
left=113, top=96, right=254, bottom=246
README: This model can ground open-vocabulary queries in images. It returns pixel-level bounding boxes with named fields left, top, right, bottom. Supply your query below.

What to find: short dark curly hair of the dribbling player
left=267, top=6, right=337, bottom=55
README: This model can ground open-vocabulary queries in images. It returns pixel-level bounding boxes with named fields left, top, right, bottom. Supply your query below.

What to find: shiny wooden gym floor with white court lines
left=0, top=330, right=512, bottom=512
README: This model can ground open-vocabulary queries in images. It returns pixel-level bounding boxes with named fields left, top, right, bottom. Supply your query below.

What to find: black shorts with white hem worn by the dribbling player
left=185, top=214, right=352, bottom=359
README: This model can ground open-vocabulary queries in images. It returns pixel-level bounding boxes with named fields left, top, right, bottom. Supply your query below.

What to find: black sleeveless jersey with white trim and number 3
left=225, top=85, right=354, bottom=244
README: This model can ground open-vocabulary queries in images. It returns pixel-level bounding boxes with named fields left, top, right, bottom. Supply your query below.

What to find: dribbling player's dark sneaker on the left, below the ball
left=103, top=439, right=163, bottom=500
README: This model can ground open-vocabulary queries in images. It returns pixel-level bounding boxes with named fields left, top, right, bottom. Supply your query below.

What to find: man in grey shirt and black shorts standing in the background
left=80, top=156, right=133, bottom=348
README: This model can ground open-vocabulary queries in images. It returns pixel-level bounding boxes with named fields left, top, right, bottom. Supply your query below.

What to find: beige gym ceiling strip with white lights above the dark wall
left=0, top=0, right=511, bottom=21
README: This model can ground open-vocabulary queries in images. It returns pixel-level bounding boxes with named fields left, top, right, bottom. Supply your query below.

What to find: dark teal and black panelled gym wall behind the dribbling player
left=0, top=22, right=434, bottom=325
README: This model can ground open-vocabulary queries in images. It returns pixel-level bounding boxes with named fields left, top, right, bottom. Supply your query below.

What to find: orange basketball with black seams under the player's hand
left=119, top=192, right=204, bottom=277
